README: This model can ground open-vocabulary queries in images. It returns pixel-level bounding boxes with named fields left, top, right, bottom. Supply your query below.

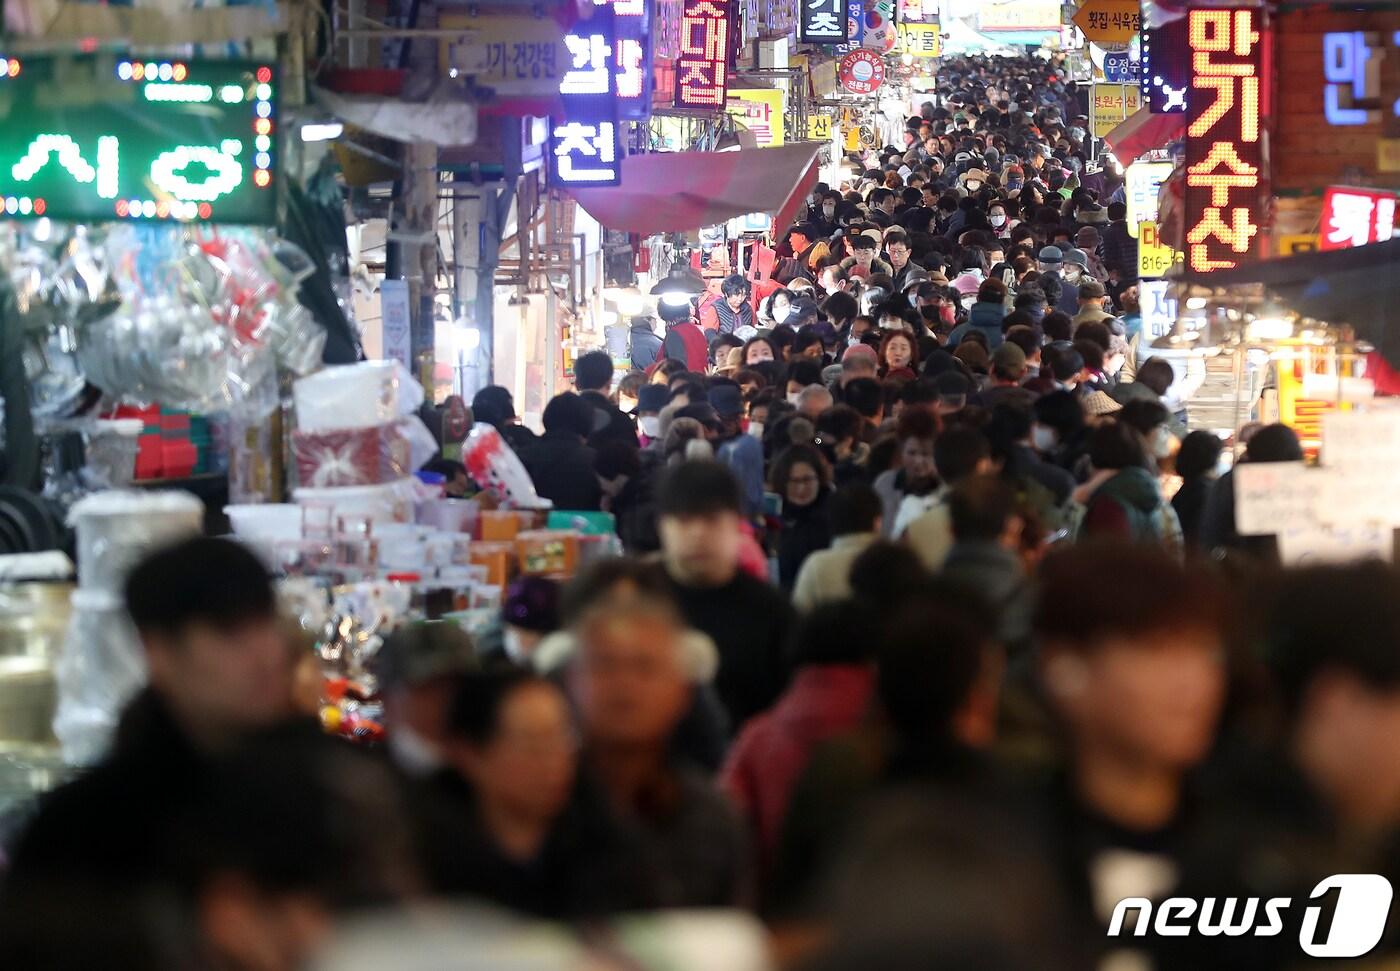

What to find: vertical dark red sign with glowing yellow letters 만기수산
left=1186, top=8, right=1267, bottom=273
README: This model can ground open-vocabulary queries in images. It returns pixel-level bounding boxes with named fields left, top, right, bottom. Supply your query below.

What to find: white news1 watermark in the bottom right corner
left=1109, top=873, right=1394, bottom=957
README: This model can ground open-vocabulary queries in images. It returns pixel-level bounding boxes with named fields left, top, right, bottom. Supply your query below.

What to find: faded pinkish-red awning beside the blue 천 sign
left=568, top=141, right=825, bottom=236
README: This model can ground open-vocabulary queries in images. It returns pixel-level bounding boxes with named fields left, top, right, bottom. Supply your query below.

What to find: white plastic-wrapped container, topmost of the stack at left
left=291, top=361, right=423, bottom=431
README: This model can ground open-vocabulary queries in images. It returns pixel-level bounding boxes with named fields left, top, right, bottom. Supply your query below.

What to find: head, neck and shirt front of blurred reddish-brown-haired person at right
left=1035, top=544, right=1231, bottom=967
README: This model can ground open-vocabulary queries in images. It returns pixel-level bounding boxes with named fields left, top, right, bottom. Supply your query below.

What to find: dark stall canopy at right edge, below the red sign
left=1182, top=239, right=1400, bottom=367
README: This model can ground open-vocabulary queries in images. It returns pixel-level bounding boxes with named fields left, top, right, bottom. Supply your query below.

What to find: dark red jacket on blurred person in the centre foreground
left=720, top=665, right=875, bottom=870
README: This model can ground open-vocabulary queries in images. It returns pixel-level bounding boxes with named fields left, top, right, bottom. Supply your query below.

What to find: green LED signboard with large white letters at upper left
left=0, top=55, right=277, bottom=224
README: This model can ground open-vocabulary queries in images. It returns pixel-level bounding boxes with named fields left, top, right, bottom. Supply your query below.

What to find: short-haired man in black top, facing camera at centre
left=657, top=462, right=792, bottom=730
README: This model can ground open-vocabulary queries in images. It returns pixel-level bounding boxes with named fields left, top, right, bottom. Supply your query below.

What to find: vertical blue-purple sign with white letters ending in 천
left=549, top=7, right=623, bottom=186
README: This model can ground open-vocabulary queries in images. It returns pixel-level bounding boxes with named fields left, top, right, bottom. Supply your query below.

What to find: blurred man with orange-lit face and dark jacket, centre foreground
left=570, top=600, right=750, bottom=907
